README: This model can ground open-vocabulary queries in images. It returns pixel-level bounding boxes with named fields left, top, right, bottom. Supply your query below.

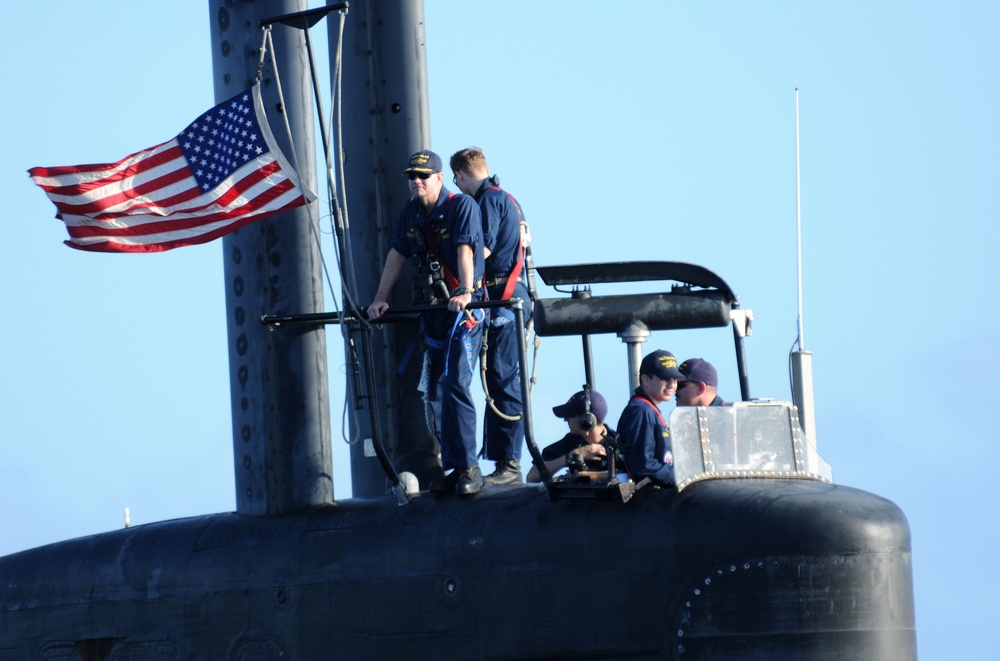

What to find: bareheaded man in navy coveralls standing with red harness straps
left=450, top=147, right=531, bottom=484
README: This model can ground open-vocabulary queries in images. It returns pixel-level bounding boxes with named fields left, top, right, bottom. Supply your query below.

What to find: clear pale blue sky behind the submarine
left=0, top=0, right=1000, bottom=660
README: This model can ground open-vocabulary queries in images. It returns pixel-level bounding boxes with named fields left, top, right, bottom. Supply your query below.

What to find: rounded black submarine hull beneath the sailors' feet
left=0, top=479, right=916, bottom=661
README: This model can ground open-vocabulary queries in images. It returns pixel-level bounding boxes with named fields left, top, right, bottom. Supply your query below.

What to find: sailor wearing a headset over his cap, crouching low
left=528, top=388, right=615, bottom=482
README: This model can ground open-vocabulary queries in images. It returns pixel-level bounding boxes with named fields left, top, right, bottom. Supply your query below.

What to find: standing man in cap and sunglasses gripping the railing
left=368, top=150, right=484, bottom=495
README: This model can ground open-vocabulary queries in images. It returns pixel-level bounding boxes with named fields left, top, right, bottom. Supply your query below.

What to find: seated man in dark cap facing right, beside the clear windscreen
left=618, top=349, right=681, bottom=486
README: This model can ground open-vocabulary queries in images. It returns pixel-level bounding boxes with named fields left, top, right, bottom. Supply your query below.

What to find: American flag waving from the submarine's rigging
left=28, top=85, right=316, bottom=252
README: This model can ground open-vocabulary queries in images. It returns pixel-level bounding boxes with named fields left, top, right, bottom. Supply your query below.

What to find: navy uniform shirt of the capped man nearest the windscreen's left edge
left=618, top=388, right=674, bottom=485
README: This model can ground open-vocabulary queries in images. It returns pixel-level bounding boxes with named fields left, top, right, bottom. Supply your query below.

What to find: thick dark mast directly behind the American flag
left=209, top=0, right=333, bottom=515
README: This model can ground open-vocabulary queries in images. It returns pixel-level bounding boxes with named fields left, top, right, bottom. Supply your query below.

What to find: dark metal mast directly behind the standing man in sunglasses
left=329, top=0, right=436, bottom=496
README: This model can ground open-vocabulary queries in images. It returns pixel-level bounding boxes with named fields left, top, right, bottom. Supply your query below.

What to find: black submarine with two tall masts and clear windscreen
left=0, top=0, right=916, bottom=661
